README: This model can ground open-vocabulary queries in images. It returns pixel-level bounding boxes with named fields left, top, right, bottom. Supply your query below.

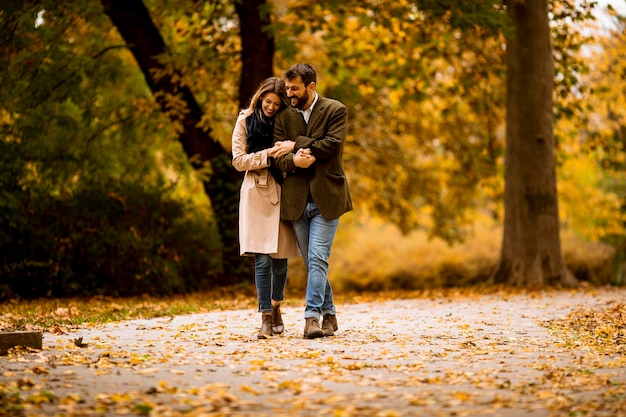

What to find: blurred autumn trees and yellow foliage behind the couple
left=0, top=0, right=626, bottom=297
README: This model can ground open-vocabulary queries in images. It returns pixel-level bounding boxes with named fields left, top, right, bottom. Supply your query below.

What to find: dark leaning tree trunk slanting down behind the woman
left=101, top=0, right=246, bottom=284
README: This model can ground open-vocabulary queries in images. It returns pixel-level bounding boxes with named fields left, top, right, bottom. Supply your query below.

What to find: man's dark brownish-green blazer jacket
left=274, top=96, right=352, bottom=220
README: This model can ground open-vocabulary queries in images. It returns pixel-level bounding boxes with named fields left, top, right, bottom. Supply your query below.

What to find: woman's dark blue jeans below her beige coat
left=254, top=253, right=287, bottom=313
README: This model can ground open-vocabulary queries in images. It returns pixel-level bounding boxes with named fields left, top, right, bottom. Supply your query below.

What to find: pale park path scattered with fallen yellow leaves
left=0, top=288, right=626, bottom=417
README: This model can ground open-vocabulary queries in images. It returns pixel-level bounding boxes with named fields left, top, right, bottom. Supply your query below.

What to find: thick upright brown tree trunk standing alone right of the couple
left=494, top=0, right=576, bottom=287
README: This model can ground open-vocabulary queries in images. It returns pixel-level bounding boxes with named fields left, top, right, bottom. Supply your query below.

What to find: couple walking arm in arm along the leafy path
left=232, top=64, right=352, bottom=339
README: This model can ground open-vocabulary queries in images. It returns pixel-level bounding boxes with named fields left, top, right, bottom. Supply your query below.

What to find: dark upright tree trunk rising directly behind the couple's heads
left=235, top=0, right=275, bottom=108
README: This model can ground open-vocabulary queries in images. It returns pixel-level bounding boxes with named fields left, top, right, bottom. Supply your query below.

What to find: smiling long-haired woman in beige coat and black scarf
left=232, top=77, right=300, bottom=339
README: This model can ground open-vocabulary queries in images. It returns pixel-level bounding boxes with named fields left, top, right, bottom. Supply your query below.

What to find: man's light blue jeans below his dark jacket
left=293, top=196, right=339, bottom=320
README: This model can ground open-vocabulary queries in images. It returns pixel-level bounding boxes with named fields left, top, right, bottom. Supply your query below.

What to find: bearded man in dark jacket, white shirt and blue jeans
left=274, top=64, right=352, bottom=339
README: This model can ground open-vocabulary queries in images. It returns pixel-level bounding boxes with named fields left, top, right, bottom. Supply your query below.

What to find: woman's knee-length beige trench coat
left=232, top=114, right=300, bottom=258
